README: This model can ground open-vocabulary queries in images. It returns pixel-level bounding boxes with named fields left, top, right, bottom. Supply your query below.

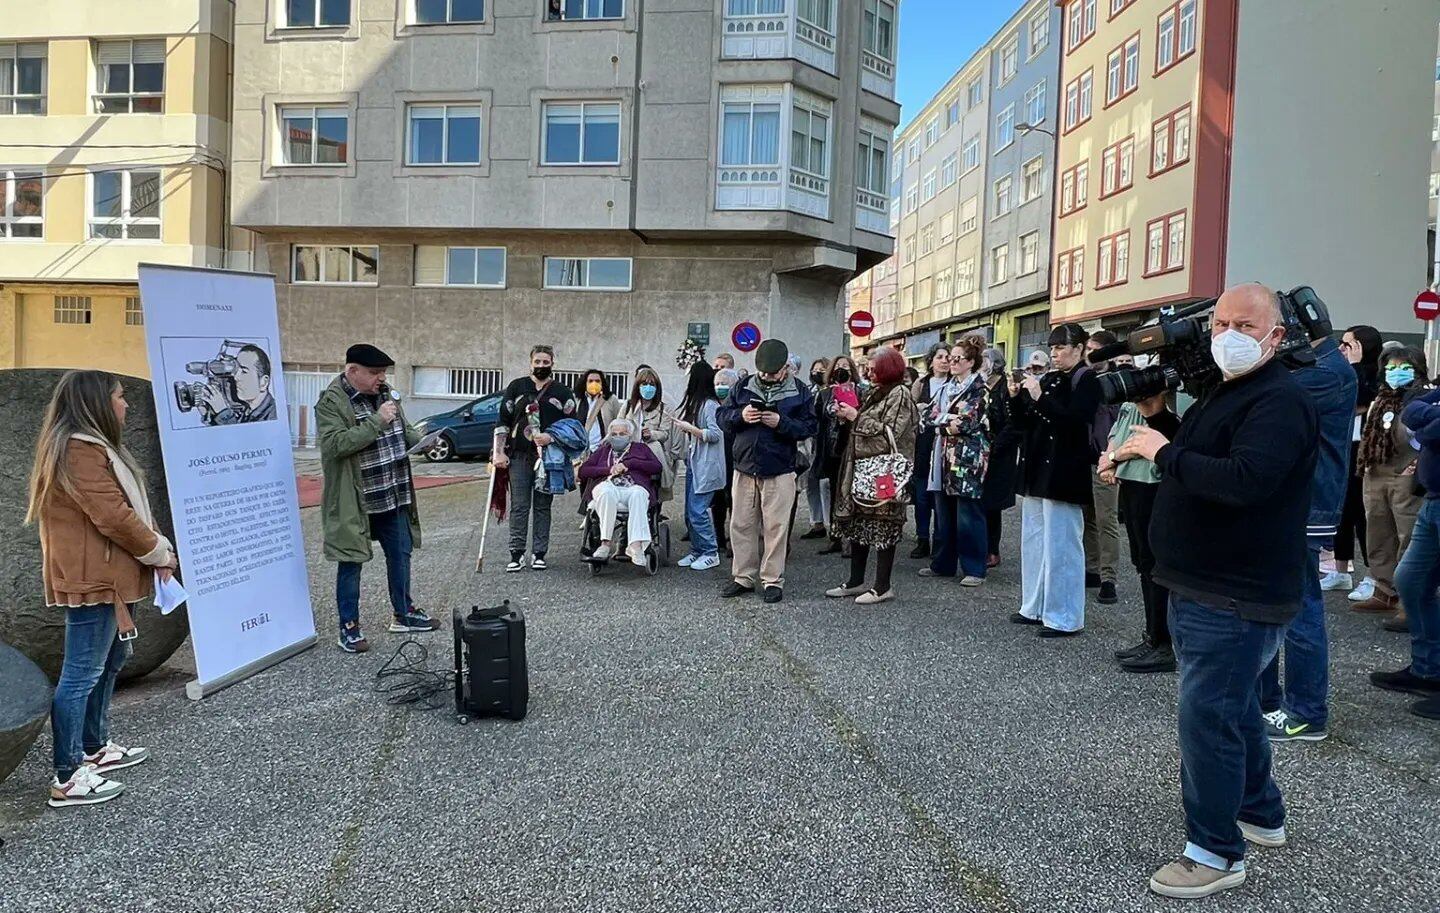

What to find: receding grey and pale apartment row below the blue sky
left=852, top=0, right=1060, bottom=368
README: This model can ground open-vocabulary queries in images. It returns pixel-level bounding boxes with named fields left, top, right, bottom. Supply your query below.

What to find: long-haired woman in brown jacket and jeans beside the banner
left=26, top=372, right=176, bottom=808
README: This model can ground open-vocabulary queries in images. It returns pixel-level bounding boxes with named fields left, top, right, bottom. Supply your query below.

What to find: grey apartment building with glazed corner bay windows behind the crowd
left=230, top=0, right=899, bottom=415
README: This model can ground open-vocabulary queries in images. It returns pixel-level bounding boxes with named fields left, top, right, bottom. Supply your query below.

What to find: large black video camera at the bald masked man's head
left=1090, top=285, right=1333, bottom=406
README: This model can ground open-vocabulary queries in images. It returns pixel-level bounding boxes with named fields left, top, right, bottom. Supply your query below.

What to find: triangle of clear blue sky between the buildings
left=897, top=0, right=1028, bottom=127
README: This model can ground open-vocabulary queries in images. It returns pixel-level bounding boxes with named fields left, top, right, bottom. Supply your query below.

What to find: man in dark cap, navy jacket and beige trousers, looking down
left=717, top=340, right=816, bottom=602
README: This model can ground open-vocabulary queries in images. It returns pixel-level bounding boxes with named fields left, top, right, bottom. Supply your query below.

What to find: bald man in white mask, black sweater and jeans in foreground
left=1106, top=285, right=1319, bottom=897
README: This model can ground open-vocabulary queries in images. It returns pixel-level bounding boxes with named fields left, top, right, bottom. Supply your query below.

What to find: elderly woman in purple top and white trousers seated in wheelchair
left=580, top=419, right=661, bottom=567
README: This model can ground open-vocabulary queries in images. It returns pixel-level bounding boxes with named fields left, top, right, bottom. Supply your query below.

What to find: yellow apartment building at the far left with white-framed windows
left=0, top=0, right=230, bottom=376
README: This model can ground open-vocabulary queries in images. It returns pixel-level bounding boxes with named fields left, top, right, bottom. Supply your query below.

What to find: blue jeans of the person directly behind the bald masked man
left=1260, top=541, right=1331, bottom=729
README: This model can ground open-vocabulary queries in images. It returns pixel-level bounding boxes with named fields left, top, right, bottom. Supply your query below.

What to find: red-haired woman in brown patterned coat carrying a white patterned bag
left=825, top=346, right=919, bottom=605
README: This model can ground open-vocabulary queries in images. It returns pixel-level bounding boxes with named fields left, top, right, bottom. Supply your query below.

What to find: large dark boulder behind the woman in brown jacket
left=0, top=369, right=190, bottom=681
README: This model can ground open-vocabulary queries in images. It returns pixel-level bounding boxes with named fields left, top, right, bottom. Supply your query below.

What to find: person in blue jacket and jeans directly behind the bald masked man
left=1260, top=319, right=1358, bottom=742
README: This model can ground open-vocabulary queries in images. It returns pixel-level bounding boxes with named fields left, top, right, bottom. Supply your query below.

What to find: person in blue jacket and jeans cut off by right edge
left=1369, top=380, right=1440, bottom=720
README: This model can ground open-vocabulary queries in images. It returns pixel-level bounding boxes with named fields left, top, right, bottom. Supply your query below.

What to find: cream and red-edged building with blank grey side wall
left=1051, top=0, right=1440, bottom=331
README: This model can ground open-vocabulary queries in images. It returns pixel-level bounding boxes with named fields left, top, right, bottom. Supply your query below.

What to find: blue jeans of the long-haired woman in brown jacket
left=50, top=605, right=130, bottom=783
